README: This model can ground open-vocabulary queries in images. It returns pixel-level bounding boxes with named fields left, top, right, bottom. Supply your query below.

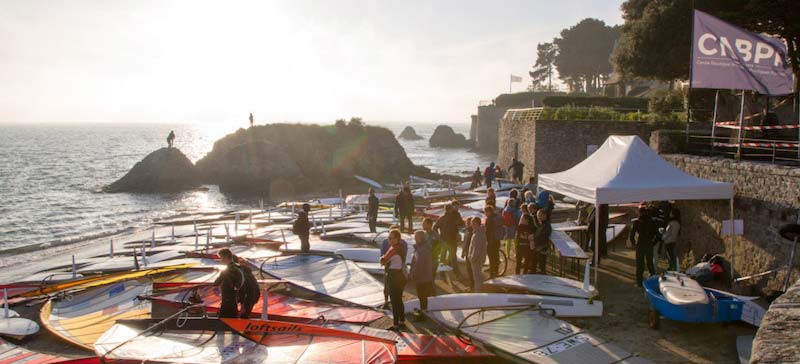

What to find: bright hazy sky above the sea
left=0, top=0, right=622, bottom=123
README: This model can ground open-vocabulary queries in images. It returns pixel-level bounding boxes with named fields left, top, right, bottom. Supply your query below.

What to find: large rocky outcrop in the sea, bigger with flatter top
left=197, top=124, right=430, bottom=198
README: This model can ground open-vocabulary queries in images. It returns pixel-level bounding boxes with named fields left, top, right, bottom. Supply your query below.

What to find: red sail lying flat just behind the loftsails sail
left=152, top=285, right=385, bottom=323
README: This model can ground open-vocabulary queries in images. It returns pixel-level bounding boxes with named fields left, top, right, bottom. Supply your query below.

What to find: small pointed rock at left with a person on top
left=103, top=148, right=200, bottom=192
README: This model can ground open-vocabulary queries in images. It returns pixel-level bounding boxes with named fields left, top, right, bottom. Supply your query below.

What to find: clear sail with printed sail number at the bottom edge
left=425, top=307, right=651, bottom=364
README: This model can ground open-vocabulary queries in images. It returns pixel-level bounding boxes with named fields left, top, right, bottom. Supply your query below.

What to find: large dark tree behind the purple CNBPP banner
left=612, top=0, right=800, bottom=89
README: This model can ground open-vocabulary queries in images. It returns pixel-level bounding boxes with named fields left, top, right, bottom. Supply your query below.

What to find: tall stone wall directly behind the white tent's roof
left=497, top=118, right=650, bottom=179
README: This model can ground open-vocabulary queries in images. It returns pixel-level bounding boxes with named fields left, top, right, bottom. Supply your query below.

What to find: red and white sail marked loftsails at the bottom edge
left=94, top=319, right=397, bottom=364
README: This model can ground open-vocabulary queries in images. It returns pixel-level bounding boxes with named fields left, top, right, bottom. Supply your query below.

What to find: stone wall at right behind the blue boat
left=662, top=154, right=800, bottom=294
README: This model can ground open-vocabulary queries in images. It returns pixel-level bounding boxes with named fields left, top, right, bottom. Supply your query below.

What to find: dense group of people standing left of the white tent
left=367, top=178, right=554, bottom=329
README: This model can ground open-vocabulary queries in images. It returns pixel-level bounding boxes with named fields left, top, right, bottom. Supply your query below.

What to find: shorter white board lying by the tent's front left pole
left=483, top=274, right=598, bottom=298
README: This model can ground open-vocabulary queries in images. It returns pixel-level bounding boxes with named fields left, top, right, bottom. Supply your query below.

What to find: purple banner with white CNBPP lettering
left=691, top=10, right=794, bottom=95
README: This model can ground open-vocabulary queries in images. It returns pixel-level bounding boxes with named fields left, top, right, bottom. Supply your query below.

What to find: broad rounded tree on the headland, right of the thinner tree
left=553, top=18, right=619, bottom=92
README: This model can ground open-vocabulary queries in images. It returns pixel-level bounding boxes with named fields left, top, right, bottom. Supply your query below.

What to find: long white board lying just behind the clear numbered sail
left=405, top=293, right=603, bottom=317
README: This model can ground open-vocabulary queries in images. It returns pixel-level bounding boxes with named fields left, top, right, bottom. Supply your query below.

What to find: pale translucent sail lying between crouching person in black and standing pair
left=259, top=254, right=384, bottom=307
